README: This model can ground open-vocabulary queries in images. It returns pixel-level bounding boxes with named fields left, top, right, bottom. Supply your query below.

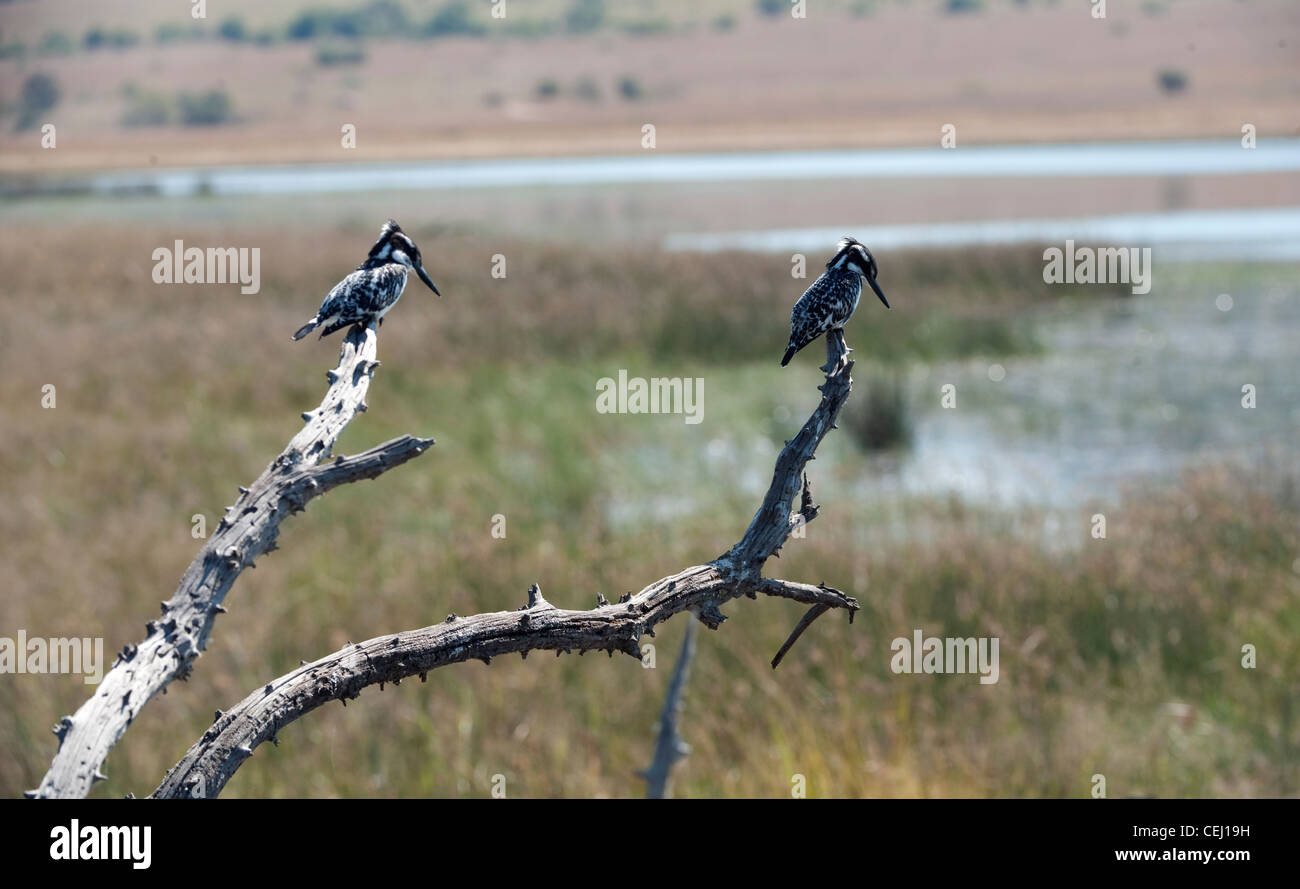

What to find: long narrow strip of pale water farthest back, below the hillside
left=68, top=139, right=1300, bottom=196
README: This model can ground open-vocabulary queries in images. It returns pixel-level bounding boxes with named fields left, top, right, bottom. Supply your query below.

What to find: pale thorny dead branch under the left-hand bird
left=29, top=328, right=433, bottom=797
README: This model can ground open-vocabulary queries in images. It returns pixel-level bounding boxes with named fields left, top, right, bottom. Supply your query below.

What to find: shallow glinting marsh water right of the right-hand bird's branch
left=859, top=265, right=1300, bottom=508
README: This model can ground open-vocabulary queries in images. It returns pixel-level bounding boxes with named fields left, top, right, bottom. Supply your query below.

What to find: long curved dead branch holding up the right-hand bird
left=151, top=335, right=858, bottom=798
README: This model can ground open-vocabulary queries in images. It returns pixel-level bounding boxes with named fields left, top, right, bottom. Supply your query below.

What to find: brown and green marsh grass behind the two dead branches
left=0, top=224, right=1300, bottom=797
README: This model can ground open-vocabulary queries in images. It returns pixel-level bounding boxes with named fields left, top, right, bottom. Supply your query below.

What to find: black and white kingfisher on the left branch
left=294, top=220, right=442, bottom=341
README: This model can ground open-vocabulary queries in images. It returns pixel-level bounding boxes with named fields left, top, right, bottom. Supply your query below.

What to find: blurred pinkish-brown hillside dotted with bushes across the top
left=0, top=0, right=1300, bottom=172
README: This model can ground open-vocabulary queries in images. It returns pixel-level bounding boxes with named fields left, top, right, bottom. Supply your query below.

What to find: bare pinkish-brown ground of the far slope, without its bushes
left=0, top=0, right=1300, bottom=172
